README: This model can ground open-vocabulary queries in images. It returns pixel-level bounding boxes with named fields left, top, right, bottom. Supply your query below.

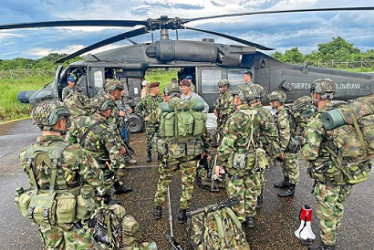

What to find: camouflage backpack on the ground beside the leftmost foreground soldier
left=93, top=204, right=157, bottom=250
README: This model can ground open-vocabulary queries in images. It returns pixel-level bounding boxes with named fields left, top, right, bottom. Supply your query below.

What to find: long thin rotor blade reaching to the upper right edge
left=181, top=7, right=374, bottom=24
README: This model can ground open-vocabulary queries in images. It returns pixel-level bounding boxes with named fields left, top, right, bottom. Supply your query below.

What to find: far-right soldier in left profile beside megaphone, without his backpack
left=301, top=79, right=366, bottom=249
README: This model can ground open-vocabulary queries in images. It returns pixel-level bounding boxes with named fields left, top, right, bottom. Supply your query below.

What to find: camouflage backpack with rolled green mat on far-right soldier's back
left=321, top=95, right=374, bottom=184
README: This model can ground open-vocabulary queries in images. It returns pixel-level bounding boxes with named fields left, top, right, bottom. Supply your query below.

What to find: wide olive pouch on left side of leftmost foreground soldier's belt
left=28, top=192, right=57, bottom=226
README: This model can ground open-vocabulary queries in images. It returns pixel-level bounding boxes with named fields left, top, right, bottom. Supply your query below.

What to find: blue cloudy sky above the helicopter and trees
left=0, top=0, right=374, bottom=59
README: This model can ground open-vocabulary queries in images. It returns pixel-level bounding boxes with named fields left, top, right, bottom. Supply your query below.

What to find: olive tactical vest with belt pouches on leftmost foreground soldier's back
left=15, top=141, right=96, bottom=227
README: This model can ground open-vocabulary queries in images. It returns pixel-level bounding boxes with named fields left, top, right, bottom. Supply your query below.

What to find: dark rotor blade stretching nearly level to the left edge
left=0, top=20, right=148, bottom=30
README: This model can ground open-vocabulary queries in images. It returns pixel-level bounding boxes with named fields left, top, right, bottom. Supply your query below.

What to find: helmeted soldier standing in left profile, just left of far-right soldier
left=268, top=91, right=299, bottom=197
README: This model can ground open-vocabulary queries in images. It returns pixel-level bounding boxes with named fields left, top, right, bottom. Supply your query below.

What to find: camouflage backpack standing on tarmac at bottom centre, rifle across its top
left=187, top=198, right=250, bottom=250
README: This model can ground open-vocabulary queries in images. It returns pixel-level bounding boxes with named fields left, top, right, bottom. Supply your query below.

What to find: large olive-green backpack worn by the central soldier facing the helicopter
left=155, top=98, right=206, bottom=158
